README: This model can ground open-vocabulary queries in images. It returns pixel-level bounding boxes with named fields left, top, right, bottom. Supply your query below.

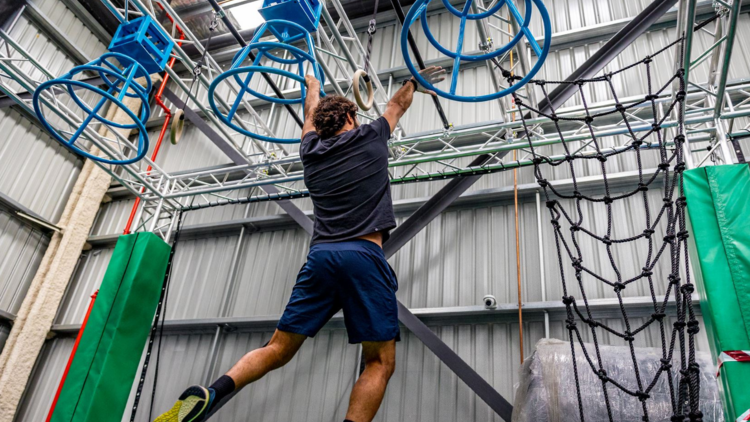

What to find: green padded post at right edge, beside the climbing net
left=684, top=164, right=750, bottom=421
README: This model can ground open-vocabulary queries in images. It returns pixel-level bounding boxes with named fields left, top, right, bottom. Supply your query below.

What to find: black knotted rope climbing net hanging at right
left=506, top=39, right=702, bottom=422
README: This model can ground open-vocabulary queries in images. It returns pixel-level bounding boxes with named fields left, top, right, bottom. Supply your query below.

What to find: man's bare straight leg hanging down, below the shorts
left=346, top=340, right=396, bottom=422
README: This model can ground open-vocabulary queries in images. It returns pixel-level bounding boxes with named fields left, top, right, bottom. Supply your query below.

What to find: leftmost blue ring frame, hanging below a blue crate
left=32, top=53, right=151, bottom=165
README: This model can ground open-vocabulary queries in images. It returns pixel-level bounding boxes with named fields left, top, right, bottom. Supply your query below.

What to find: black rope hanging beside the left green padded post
left=130, top=211, right=188, bottom=422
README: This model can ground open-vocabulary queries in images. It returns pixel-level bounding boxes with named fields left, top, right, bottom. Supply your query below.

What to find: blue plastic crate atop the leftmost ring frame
left=109, top=16, right=174, bottom=74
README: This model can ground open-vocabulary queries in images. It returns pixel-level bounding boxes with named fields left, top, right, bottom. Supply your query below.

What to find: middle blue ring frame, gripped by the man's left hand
left=208, top=20, right=325, bottom=144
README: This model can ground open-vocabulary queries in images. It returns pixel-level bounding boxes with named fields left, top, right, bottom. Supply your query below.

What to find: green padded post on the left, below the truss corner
left=51, top=233, right=170, bottom=422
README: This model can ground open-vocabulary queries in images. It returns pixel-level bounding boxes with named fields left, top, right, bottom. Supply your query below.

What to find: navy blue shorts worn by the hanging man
left=277, top=239, right=399, bottom=343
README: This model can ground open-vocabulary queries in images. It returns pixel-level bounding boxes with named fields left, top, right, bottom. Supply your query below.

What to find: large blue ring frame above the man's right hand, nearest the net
left=401, top=0, right=552, bottom=103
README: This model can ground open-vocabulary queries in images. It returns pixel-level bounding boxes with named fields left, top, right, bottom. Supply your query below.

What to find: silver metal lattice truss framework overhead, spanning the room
left=0, top=0, right=750, bottom=214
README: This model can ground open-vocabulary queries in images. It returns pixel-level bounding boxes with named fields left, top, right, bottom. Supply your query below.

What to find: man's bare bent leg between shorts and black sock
left=227, top=330, right=307, bottom=390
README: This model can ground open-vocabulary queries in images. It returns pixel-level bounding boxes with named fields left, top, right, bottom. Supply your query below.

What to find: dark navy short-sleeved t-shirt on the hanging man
left=300, top=117, right=396, bottom=245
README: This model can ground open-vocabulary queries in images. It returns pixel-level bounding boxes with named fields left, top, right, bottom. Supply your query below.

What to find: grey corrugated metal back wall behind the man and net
left=16, top=0, right=750, bottom=422
